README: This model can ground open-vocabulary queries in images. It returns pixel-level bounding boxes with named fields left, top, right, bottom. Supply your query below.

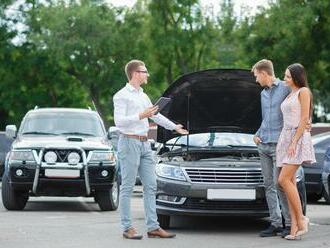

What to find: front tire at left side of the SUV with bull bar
left=1, top=173, right=29, bottom=210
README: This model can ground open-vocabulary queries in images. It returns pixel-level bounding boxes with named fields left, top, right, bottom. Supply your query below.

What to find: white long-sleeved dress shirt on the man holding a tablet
left=113, top=83, right=176, bottom=136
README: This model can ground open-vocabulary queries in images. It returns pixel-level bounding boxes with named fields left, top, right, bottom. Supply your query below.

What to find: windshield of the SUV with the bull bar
left=20, top=112, right=105, bottom=137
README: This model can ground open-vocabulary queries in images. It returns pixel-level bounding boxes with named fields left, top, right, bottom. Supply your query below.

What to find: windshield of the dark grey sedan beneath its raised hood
left=166, top=133, right=256, bottom=147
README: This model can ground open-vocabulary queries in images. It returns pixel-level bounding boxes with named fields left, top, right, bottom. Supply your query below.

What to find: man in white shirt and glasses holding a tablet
left=113, top=60, right=188, bottom=239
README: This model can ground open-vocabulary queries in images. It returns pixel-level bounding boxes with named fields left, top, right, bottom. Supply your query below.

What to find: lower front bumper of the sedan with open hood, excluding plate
left=156, top=178, right=269, bottom=217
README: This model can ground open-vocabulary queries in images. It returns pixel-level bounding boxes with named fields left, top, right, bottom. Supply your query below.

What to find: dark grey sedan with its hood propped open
left=156, top=69, right=306, bottom=227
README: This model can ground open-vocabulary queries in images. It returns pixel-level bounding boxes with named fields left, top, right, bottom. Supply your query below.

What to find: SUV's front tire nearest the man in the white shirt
left=95, top=181, right=120, bottom=211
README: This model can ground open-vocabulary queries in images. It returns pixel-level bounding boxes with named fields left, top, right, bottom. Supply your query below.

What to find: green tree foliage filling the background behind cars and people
left=0, top=0, right=330, bottom=129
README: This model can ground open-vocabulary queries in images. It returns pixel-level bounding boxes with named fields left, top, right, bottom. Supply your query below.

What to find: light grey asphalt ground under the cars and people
left=0, top=187, right=330, bottom=248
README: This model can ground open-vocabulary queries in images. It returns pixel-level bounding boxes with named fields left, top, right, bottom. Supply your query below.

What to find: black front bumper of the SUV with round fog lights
left=8, top=148, right=116, bottom=196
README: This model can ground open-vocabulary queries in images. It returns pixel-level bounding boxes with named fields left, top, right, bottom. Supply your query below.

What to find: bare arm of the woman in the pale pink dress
left=288, top=87, right=311, bottom=156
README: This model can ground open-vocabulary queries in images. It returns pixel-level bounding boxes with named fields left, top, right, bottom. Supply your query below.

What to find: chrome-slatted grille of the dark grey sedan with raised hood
left=185, top=168, right=263, bottom=184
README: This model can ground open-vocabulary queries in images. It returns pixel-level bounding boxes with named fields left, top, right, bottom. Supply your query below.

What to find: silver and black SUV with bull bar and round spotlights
left=2, top=108, right=119, bottom=211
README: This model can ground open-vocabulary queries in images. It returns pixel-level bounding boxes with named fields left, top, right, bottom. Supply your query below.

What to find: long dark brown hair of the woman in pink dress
left=287, top=63, right=313, bottom=117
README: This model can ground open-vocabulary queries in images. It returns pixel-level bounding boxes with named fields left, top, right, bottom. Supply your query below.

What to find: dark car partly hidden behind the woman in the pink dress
left=303, top=132, right=330, bottom=201
